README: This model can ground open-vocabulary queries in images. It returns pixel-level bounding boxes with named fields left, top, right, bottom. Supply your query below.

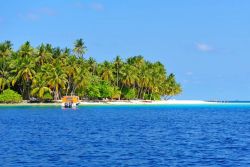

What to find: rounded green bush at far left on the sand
left=0, top=89, right=22, bottom=103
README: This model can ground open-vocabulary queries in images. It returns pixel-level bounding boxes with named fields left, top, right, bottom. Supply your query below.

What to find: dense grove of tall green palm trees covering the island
left=0, top=39, right=181, bottom=101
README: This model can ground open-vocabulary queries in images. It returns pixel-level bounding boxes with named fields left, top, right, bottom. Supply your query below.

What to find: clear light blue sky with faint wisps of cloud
left=0, top=0, right=250, bottom=100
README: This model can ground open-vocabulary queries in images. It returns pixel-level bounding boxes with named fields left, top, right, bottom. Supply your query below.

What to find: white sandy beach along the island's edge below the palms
left=0, top=100, right=219, bottom=106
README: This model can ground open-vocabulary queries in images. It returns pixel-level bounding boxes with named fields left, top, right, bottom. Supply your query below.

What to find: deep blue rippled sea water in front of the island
left=0, top=104, right=250, bottom=167
